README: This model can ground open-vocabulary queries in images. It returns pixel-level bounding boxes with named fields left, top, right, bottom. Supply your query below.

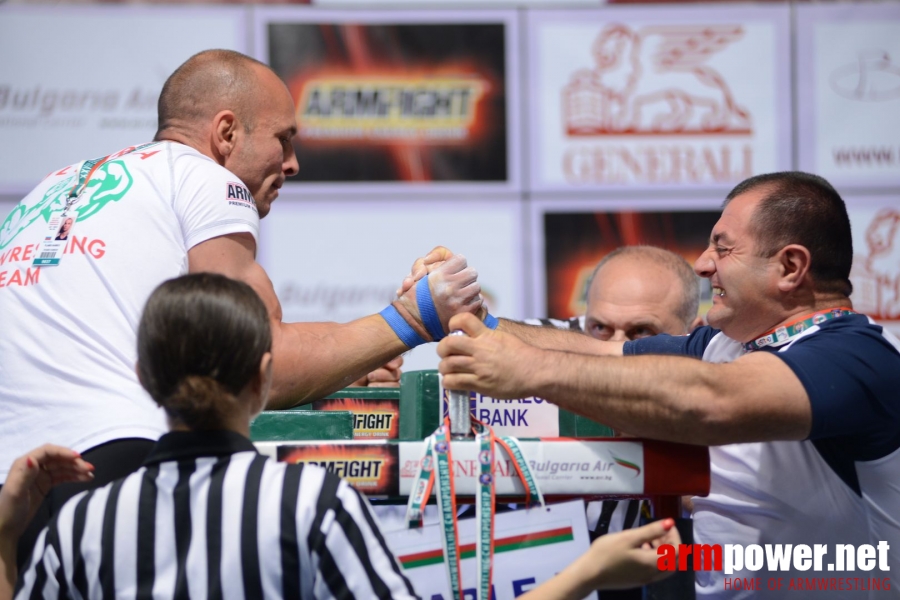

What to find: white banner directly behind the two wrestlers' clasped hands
left=259, top=195, right=525, bottom=371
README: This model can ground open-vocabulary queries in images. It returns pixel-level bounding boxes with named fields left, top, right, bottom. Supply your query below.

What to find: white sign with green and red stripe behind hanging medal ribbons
left=384, top=500, right=596, bottom=600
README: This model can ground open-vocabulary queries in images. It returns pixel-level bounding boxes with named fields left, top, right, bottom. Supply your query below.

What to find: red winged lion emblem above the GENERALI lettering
left=563, top=24, right=752, bottom=136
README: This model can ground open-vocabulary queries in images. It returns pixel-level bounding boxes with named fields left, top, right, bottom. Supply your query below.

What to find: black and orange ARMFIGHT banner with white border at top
left=257, top=8, right=518, bottom=191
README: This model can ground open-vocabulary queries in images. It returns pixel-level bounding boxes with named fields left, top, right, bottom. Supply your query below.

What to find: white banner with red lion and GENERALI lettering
left=527, top=6, right=791, bottom=191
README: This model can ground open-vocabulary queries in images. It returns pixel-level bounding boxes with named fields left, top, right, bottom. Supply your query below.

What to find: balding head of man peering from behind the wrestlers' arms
left=585, top=246, right=700, bottom=340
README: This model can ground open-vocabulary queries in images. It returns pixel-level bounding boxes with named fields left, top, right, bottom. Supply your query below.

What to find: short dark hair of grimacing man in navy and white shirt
left=725, top=171, right=853, bottom=296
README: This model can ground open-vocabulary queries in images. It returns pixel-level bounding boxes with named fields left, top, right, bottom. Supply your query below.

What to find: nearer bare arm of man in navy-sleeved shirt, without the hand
left=529, top=351, right=811, bottom=445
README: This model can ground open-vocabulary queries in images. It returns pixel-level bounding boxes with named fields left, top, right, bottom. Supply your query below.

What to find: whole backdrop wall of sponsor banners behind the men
left=0, top=3, right=900, bottom=367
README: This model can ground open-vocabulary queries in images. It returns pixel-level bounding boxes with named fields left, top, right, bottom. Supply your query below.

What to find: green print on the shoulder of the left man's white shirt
left=0, top=160, right=134, bottom=250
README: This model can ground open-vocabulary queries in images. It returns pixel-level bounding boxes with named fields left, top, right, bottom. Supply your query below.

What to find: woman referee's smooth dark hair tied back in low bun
left=138, top=273, right=272, bottom=430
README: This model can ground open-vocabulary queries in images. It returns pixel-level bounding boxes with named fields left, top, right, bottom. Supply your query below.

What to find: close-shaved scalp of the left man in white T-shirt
left=156, top=50, right=274, bottom=140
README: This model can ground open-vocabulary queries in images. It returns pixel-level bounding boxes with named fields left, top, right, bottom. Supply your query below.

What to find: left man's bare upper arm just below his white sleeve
left=188, top=233, right=281, bottom=321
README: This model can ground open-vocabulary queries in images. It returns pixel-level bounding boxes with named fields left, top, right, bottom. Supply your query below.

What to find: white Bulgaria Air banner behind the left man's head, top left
left=0, top=6, right=246, bottom=196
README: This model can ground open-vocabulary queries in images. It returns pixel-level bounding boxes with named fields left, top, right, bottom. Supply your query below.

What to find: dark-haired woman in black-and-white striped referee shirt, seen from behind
left=16, top=274, right=416, bottom=599
